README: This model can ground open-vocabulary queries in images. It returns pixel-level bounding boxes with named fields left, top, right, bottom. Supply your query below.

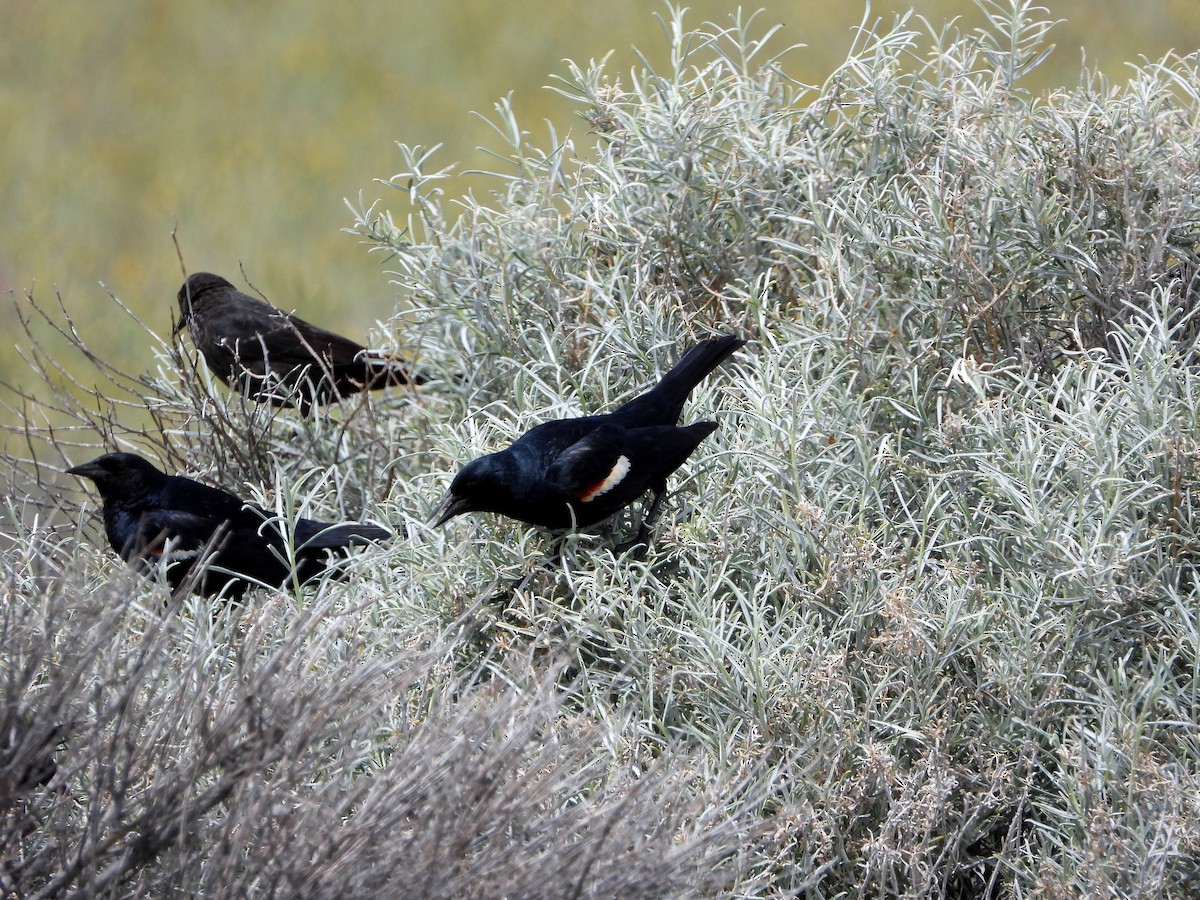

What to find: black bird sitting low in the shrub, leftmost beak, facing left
left=67, top=454, right=391, bottom=599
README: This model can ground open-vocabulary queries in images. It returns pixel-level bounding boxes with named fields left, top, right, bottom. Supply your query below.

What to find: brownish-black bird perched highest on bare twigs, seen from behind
left=174, top=272, right=428, bottom=410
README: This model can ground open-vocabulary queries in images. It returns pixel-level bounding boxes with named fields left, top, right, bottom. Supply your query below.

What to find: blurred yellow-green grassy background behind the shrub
left=0, top=0, right=1200, bottom=393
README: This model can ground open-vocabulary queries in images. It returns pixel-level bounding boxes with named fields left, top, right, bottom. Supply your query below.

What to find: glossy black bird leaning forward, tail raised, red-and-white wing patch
left=433, top=336, right=745, bottom=545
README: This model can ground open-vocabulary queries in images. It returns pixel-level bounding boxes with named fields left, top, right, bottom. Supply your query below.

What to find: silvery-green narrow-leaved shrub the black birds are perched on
left=6, top=0, right=1200, bottom=898
